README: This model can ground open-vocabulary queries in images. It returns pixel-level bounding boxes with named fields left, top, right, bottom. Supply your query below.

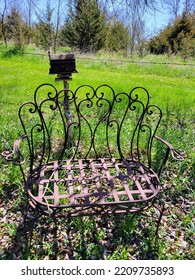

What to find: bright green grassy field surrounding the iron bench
left=0, top=44, right=195, bottom=259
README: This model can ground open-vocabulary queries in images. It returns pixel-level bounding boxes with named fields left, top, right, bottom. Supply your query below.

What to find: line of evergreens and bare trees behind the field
left=0, top=0, right=195, bottom=57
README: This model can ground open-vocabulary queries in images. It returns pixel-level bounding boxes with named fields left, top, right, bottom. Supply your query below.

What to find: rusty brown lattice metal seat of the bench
left=27, top=158, right=160, bottom=217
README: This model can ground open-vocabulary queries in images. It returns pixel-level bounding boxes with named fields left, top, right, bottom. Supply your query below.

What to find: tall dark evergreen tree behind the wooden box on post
left=61, top=0, right=105, bottom=52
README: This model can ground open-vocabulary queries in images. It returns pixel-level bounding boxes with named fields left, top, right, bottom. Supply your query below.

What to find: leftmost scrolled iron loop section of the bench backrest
left=18, top=84, right=57, bottom=172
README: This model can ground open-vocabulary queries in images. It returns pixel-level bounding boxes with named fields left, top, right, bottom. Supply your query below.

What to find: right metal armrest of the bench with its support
left=154, top=135, right=187, bottom=177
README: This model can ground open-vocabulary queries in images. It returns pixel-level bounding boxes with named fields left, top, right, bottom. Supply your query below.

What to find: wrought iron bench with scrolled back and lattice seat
left=2, top=84, right=185, bottom=234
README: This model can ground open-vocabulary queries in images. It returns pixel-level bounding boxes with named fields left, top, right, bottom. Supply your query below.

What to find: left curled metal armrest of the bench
left=1, top=135, right=27, bottom=165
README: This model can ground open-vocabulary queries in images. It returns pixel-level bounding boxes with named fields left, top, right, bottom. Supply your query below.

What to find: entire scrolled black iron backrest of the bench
left=16, top=84, right=162, bottom=171
